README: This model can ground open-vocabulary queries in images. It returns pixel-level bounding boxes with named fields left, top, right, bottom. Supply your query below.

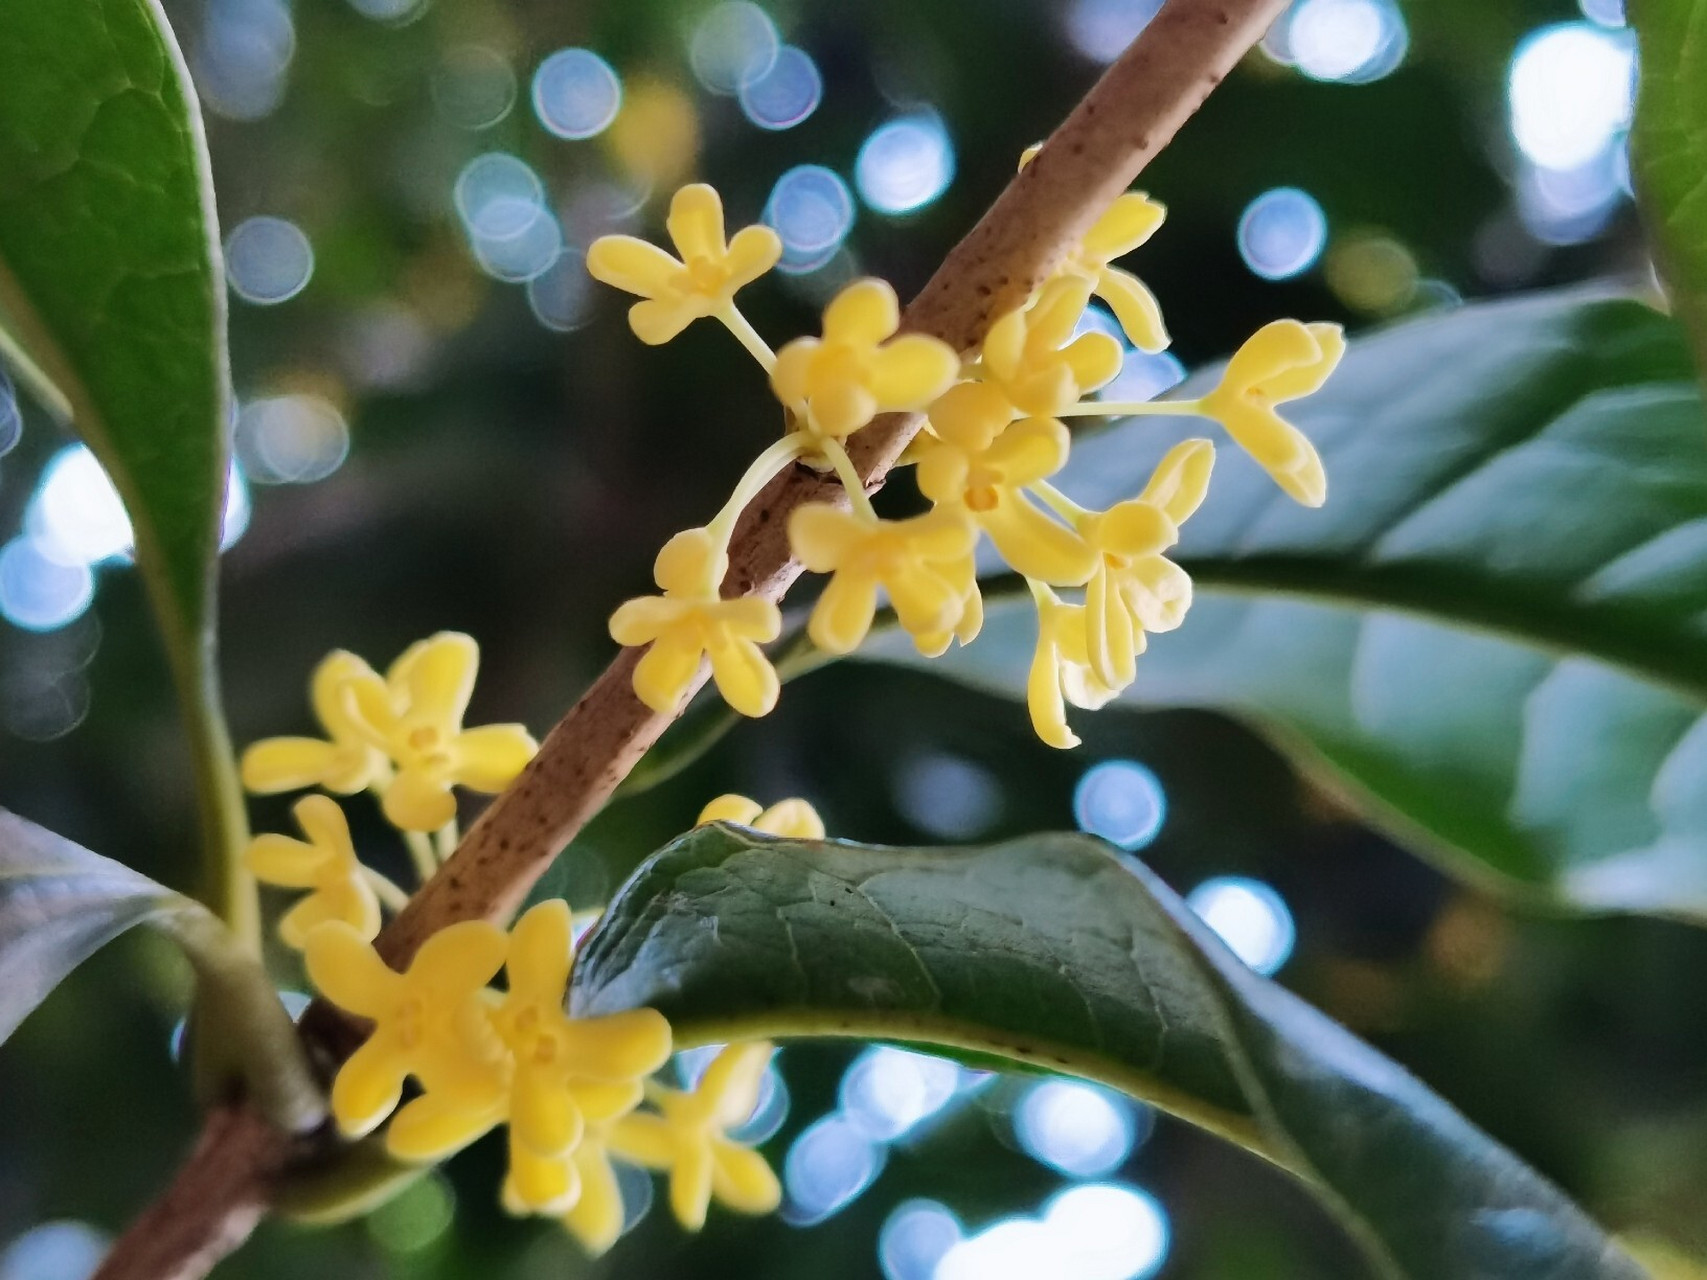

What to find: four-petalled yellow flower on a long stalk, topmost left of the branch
left=587, top=183, right=782, bottom=345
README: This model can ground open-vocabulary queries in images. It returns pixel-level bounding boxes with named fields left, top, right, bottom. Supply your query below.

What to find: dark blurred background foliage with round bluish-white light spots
left=0, top=0, right=1707, bottom=1280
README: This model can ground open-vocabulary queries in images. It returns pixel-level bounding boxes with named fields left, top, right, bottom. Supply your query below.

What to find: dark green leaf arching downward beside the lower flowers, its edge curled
left=570, top=824, right=1642, bottom=1280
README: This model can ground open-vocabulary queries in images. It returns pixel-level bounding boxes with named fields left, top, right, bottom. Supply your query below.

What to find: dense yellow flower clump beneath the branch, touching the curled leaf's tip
left=304, top=901, right=782, bottom=1254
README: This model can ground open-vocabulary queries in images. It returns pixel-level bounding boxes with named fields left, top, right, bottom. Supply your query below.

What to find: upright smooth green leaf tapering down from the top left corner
left=0, top=0, right=253, bottom=934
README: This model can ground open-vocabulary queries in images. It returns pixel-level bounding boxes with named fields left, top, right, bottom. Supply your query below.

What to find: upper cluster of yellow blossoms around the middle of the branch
left=587, top=165, right=1345, bottom=748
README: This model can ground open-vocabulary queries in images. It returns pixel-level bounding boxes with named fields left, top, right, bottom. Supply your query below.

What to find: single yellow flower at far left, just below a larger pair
left=242, top=795, right=379, bottom=951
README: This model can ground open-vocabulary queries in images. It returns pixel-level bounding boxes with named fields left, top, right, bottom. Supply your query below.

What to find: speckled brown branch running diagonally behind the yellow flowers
left=97, top=0, right=1287, bottom=1280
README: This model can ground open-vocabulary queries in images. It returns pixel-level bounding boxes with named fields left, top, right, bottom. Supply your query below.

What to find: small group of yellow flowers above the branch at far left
left=241, top=631, right=538, bottom=949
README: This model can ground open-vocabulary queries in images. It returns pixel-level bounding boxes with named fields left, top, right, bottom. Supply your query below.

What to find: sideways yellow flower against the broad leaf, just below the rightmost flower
left=1079, top=440, right=1215, bottom=703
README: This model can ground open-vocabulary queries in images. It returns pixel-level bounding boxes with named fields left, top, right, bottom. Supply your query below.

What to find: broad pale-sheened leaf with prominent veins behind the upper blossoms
left=872, top=295, right=1707, bottom=920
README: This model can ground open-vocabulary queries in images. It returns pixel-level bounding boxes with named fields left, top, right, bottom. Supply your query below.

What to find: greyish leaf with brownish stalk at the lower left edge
left=0, top=809, right=326, bottom=1133
